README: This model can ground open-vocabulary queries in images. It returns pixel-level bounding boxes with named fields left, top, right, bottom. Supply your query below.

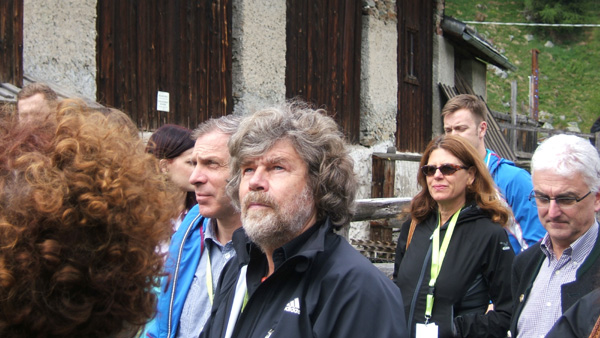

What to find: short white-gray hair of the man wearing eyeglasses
left=531, top=134, right=600, bottom=193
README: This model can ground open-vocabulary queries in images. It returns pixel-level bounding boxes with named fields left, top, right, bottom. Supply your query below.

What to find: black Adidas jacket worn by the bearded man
left=200, top=221, right=407, bottom=338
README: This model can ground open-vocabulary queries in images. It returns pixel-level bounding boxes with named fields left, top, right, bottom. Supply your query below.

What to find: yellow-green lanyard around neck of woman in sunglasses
left=425, top=208, right=462, bottom=324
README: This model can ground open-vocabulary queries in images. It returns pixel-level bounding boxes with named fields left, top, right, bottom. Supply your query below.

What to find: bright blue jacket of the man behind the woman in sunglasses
left=485, top=149, right=546, bottom=254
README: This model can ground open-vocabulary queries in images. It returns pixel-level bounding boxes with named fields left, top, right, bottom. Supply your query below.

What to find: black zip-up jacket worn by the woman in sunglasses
left=394, top=204, right=515, bottom=338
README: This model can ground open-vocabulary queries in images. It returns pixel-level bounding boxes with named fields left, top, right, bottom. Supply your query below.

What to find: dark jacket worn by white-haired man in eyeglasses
left=510, top=228, right=600, bottom=337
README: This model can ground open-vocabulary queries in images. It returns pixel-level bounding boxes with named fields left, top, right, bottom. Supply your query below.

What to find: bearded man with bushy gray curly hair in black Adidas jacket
left=201, top=101, right=407, bottom=338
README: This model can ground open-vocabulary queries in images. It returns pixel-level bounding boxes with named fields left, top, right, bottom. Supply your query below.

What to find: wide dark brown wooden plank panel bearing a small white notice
left=97, top=0, right=233, bottom=130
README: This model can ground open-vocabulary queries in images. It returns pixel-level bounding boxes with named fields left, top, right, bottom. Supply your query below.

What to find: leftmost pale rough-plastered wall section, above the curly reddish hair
left=23, top=0, right=97, bottom=100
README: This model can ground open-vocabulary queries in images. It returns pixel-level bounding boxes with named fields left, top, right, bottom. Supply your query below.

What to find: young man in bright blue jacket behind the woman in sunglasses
left=442, top=94, right=546, bottom=254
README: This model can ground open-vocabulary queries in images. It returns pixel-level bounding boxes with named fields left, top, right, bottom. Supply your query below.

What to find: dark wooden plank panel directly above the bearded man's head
left=285, top=0, right=362, bottom=142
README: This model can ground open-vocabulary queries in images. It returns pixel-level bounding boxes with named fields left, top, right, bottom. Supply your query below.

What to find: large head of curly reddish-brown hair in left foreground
left=0, top=100, right=177, bottom=337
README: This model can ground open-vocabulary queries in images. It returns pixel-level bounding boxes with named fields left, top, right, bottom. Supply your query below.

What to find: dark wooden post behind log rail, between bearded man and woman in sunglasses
left=369, top=147, right=396, bottom=242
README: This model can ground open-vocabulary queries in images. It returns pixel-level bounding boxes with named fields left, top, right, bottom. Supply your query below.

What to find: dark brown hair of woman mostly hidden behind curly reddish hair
left=146, top=124, right=195, bottom=159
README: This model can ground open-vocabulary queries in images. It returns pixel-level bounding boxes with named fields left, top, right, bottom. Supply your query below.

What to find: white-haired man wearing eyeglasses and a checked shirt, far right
left=511, top=135, right=600, bottom=337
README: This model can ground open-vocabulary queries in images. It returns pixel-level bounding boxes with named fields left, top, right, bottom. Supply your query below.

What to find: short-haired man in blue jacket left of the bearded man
left=146, top=115, right=241, bottom=338
